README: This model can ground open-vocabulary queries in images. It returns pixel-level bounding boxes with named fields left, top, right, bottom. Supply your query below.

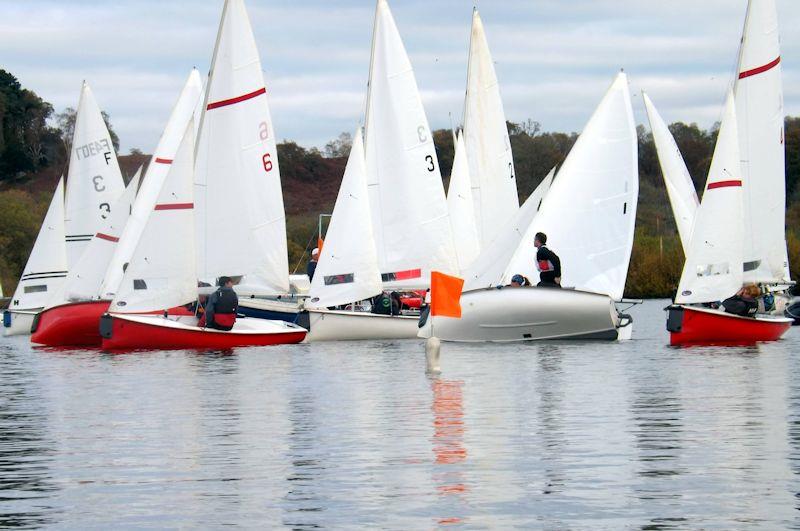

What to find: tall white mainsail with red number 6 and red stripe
left=195, top=0, right=289, bottom=294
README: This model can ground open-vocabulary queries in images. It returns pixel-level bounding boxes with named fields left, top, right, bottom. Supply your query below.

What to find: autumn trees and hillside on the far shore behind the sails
left=0, top=70, right=800, bottom=297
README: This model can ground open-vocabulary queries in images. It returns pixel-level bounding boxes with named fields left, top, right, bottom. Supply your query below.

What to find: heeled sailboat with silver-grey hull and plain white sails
left=419, top=73, right=639, bottom=342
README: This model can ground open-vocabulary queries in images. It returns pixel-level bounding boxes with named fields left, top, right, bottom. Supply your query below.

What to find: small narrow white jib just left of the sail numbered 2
left=447, top=133, right=480, bottom=272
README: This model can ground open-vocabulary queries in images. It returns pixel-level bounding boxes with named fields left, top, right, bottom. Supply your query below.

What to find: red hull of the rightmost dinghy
left=667, top=306, right=792, bottom=345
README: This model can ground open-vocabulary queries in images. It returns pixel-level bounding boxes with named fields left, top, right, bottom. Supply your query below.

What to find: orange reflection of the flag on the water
left=431, top=378, right=469, bottom=525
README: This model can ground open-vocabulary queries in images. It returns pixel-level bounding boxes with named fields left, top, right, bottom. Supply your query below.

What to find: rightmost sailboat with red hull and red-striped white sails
left=667, top=0, right=792, bottom=344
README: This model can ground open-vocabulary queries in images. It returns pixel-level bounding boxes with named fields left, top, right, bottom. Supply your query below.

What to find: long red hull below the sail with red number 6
left=103, top=317, right=306, bottom=350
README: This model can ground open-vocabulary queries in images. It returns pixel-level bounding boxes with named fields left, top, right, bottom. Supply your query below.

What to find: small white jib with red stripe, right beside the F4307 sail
left=60, top=167, right=142, bottom=304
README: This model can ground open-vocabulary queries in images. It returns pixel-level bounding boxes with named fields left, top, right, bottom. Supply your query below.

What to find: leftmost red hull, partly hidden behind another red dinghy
left=31, top=301, right=111, bottom=347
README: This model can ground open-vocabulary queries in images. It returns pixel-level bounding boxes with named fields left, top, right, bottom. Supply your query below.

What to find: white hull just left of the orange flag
left=300, top=310, right=419, bottom=342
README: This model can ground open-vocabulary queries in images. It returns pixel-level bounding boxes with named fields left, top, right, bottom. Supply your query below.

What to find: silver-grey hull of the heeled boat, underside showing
left=419, top=287, right=633, bottom=342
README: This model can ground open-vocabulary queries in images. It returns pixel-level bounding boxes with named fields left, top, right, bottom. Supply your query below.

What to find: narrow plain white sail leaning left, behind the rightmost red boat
left=642, top=92, right=700, bottom=254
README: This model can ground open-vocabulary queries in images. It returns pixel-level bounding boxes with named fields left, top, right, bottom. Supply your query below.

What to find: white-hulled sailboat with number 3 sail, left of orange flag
left=298, top=0, right=458, bottom=341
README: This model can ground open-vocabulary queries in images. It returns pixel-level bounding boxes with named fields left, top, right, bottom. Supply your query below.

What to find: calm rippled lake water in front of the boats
left=0, top=301, right=800, bottom=529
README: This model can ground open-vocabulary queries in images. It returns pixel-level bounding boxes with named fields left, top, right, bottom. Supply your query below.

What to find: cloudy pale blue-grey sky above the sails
left=0, top=0, right=800, bottom=153
